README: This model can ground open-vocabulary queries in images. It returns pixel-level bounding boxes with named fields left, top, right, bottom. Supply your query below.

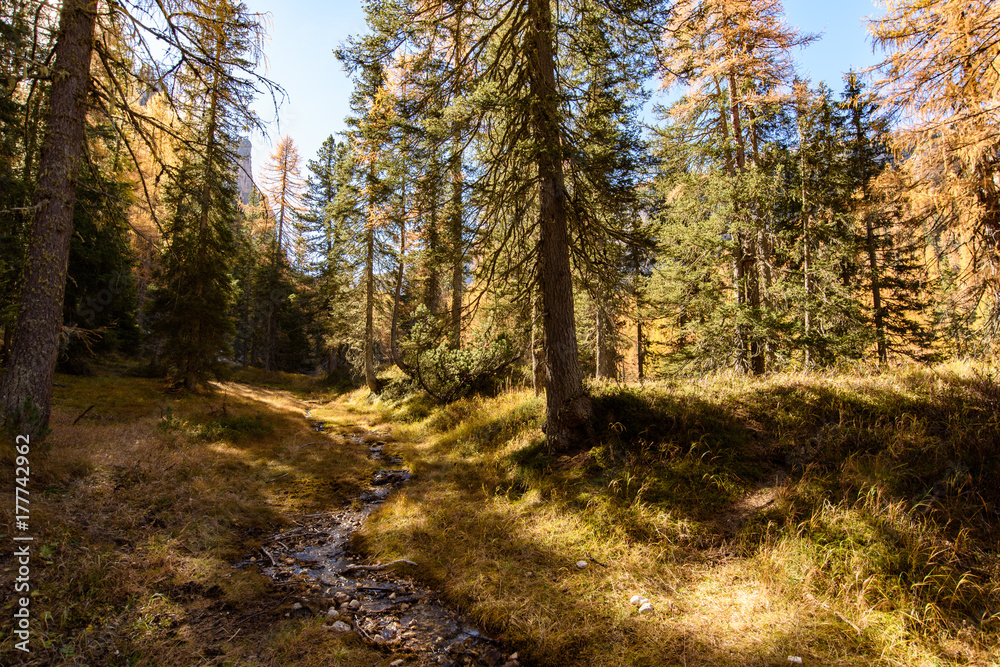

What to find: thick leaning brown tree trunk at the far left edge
left=0, top=0, right=97, bottom=434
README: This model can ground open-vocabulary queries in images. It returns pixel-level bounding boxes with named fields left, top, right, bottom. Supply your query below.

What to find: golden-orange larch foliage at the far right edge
left=870, top=0, right=1000, bottom=338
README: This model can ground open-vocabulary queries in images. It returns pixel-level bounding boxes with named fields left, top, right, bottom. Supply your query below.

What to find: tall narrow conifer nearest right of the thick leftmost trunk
left=149, top=0, right=260, bottom=389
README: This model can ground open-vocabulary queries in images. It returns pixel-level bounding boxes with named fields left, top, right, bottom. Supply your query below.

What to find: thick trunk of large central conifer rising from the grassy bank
left=527, top=0, right=593, bottom=451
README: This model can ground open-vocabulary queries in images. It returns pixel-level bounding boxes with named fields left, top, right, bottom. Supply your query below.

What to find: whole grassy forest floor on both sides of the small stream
left=0, top=364, right=1000, bottom=666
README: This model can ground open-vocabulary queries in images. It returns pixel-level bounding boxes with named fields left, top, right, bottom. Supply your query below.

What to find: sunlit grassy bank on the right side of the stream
left=363, top=365, right=1000, bottom=666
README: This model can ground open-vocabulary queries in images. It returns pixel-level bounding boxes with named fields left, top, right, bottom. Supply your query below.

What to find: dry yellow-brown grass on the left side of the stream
left=0, top=376, right=387, bottom=667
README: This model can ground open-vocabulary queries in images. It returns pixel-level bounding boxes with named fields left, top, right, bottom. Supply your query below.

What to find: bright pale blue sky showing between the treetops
left=246, top=0, right=881, bottom=180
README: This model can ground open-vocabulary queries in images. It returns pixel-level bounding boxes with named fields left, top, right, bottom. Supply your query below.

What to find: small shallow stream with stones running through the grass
left=234, top=413, right=521, bottom=667
